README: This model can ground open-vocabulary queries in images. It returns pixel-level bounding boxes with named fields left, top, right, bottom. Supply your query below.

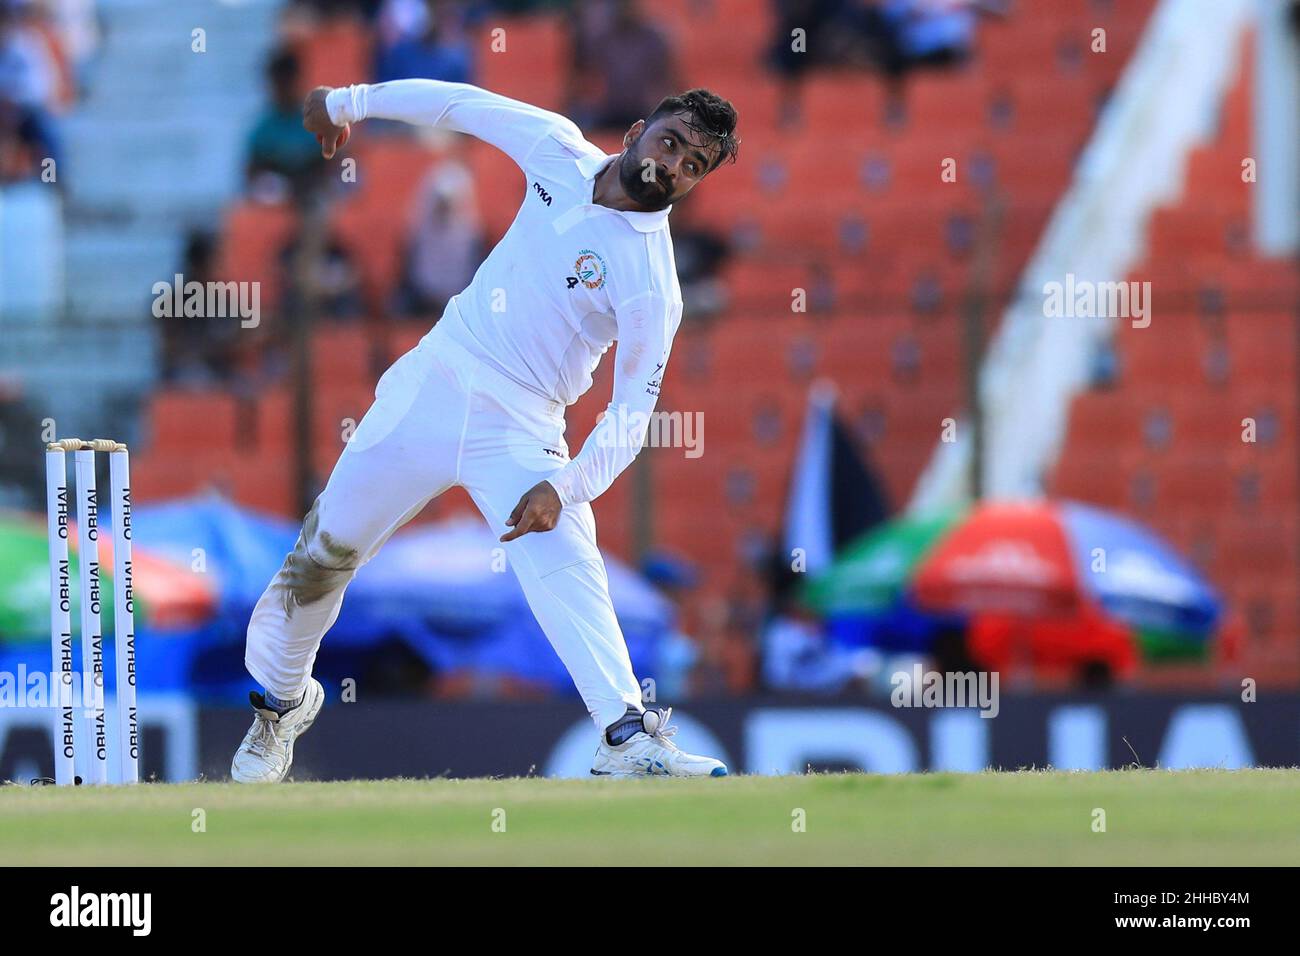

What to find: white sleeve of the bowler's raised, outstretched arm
left=313, top=79, right=576, bottom=165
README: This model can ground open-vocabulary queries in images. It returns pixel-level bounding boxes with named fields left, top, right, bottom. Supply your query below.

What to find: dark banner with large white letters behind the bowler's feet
left=0, top=693, right=1300, bottom=782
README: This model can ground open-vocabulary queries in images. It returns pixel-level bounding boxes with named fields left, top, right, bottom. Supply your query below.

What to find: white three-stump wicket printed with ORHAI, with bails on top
left=46, top=438, right=140, bottom=786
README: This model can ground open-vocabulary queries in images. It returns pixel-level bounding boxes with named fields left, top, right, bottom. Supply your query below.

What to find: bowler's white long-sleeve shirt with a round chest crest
left=325, top=79, right=681, bottom=505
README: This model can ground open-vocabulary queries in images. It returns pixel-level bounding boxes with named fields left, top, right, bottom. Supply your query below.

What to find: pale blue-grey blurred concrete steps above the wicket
left=26, top=0, right=280, bottom=438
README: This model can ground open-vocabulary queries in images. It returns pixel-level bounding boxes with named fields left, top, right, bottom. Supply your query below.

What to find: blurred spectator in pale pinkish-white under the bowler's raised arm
left=394, top=143, right=485, bottom=316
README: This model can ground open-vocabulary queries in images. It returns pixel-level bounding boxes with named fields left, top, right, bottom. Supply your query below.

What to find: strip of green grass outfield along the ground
left=0, top=770, right=1300, bottom=866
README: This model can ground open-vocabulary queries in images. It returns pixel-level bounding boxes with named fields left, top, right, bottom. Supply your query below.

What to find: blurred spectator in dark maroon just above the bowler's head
left=567, top=0, right=681, bottom=133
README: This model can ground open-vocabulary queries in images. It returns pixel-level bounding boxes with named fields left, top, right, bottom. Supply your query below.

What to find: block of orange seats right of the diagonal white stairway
left=1052, top=27, right=1300, bottom=672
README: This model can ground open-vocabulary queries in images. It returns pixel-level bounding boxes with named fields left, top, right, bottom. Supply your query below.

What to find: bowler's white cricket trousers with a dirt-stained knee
left=244, top=317, right=641, bottom=731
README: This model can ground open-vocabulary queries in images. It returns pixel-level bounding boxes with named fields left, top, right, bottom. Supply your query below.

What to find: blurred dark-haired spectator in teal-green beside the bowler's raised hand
left=248, top=49, right=324, bottom=200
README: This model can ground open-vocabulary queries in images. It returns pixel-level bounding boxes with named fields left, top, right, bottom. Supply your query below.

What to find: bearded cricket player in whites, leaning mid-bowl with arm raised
left=230, top=79, right=738, bottom=783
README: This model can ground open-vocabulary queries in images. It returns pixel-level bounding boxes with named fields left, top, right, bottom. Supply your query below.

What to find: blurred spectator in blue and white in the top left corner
left=0, top=0, right=61, bottom=182
